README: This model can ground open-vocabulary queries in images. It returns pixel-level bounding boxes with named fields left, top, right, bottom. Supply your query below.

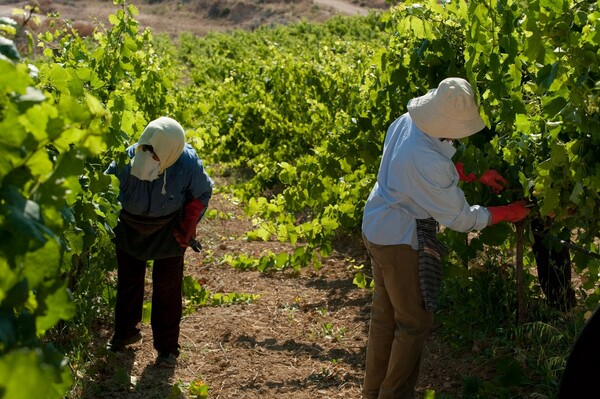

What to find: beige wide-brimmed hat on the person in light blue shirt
left=407, top=78, right=485, bottom=139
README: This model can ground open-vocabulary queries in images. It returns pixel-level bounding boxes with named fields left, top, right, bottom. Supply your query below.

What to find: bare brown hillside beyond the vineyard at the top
left=0, top=0, right=389, bottom=37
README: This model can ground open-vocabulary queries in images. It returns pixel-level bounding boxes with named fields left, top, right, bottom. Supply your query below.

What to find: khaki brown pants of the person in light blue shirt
left=363, top=237, right=433, bottom=399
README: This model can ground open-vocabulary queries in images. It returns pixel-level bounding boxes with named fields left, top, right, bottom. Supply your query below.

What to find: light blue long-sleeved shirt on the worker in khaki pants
left=362, top=113, right=490, bottom=250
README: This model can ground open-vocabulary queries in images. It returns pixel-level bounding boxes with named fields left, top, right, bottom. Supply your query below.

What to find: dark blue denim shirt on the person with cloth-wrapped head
left=106, top=143, right=213, bottom=217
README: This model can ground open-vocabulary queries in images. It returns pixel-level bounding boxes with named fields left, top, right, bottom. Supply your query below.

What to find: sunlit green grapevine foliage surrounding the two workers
left=0, top=0, right=600, bottom=398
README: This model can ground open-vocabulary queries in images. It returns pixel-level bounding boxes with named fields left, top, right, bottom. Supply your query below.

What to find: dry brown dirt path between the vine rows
left=70, top=181, right=473, bottom=399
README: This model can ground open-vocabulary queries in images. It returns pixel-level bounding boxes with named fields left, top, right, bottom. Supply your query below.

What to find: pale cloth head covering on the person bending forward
left=134, top=116, right=185, bottom=195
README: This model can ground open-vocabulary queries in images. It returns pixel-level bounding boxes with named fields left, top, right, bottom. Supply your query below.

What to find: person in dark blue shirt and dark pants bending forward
left=106, top=117, right=213, bottom=368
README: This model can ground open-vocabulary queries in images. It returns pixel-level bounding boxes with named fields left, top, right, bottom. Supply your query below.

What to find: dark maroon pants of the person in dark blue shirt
left=115, top=248, right=183, bottom=355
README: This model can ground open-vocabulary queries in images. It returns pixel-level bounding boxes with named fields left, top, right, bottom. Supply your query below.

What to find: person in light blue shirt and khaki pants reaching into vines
left=362, top=78, right=529, bottom=399
